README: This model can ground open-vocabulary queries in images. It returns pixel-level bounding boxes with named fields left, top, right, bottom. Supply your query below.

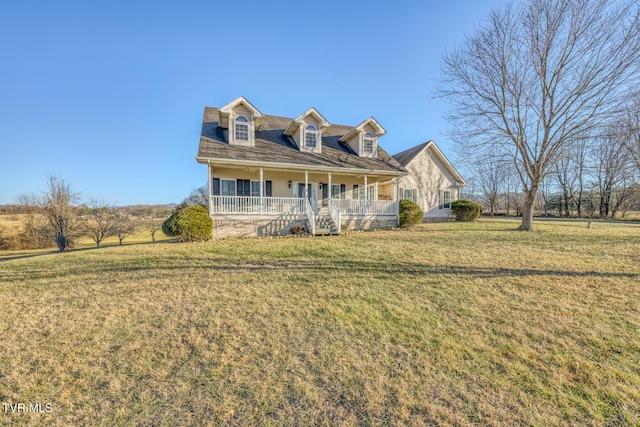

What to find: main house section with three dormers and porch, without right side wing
left=196, top=97, right=407, bottom=238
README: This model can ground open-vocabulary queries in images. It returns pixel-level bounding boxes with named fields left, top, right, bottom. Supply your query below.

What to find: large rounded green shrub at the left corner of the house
left=162, top=205, right=213, bottom=242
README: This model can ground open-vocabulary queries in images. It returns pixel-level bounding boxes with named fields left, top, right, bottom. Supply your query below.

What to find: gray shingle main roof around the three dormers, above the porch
left=198, top=107, right=406, bottom=174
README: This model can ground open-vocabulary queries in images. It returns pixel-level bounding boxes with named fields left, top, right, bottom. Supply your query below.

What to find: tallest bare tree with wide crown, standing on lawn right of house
left=439, top=0, right=640, bottom=230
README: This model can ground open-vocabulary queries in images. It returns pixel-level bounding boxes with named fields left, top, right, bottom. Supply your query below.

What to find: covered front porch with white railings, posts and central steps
left=209, top=164, right=398, bottom=236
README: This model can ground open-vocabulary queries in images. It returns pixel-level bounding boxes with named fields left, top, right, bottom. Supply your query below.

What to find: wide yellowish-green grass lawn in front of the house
left=0, top=220, right=640, bottom=426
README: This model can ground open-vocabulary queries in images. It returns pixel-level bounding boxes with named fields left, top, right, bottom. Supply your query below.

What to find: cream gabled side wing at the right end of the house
left=394, top=141, right=466, bottom=221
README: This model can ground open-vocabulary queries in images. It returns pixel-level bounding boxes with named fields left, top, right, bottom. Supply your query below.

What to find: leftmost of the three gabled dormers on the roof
left=220, top=96, right=263, bottom=147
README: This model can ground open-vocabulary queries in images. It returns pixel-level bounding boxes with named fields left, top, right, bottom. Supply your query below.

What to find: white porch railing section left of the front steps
left=211, top=196, right=305, bottom=215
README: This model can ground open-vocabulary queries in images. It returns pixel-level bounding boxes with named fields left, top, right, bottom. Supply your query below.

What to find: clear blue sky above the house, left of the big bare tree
left=0, top=0, right=501, bottom=205
